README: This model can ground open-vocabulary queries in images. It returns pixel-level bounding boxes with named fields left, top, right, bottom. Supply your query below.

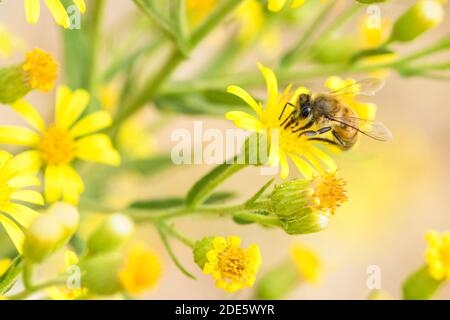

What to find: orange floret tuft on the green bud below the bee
left=309, top=172, right=348, bottom=214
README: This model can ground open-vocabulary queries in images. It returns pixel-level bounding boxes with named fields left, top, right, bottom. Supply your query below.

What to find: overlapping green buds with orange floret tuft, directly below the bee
left=271, top=173, right=347, bottom=234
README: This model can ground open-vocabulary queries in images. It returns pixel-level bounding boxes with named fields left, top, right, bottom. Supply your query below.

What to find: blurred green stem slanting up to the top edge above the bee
left=280, top=1, right=336, bottom=68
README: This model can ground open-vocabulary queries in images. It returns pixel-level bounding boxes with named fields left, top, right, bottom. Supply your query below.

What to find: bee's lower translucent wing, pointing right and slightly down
left=330, top=117, right=393, bottom=141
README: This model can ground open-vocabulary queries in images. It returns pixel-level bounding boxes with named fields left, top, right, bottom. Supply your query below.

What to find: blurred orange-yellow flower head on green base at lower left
left=119, top=243, right=162, bottom=294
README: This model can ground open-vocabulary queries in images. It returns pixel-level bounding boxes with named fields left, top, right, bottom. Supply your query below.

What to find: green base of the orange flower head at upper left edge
left=0, top=66, right=31, bottom=104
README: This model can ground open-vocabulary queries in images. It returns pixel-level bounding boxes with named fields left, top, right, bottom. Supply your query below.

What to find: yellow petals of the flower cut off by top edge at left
left=24, top=0, right=86, bottom=29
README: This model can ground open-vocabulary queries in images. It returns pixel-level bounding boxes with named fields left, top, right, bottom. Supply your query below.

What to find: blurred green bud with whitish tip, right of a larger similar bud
left=88, top=213, right=134, bottom=254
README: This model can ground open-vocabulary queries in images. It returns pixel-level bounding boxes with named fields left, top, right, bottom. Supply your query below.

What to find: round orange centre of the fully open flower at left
left=38, top=126, right=75, bottom=165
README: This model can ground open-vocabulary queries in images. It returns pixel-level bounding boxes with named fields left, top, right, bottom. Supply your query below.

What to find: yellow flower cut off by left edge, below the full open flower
left=0, top=151, right=44, bottom=253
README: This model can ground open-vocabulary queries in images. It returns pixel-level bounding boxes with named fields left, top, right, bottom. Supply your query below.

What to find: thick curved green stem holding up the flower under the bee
left=186, top=163, right=246, bottom=207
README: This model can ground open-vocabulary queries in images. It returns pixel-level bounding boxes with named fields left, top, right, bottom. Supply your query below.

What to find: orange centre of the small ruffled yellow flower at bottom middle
left=218, top=246, right=248, bottom=280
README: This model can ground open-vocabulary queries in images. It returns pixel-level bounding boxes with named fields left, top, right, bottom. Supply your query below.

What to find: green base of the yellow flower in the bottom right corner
left=403, top=266, right=443, bottom=300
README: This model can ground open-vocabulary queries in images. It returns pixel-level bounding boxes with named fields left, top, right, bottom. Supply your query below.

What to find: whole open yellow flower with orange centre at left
left=0, top=86, right=120, bottom=204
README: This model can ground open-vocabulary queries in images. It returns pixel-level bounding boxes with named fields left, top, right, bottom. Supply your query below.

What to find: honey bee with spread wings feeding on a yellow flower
left=279, top=78, right=392, bottom=151
